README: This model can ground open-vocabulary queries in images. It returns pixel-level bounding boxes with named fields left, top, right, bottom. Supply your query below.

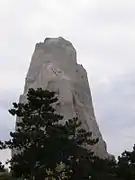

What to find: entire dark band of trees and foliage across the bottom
left=0, top=88, right=135, bottom=180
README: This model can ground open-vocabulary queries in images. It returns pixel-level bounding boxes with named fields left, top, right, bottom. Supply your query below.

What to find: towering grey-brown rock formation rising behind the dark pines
left=20, top=37, right=108, bottom=158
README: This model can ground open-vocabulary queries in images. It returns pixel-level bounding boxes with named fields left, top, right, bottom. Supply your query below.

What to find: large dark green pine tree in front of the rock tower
left=0, top=88, right=98, bottom=180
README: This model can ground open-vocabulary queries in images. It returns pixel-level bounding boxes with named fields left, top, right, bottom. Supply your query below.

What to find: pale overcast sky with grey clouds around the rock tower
left=0, top=0, right=135, bottom=160
